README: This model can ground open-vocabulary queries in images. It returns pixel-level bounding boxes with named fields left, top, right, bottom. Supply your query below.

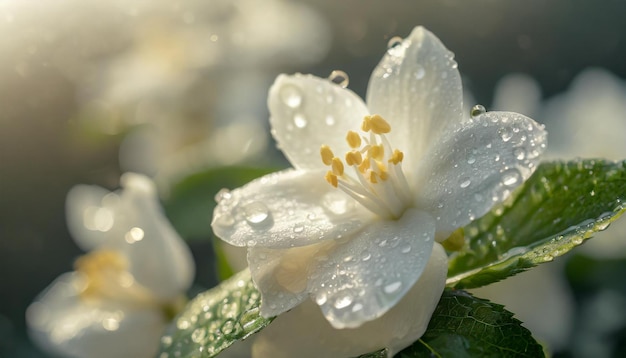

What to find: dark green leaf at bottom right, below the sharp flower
left=362, top=289, right=544, bottom=358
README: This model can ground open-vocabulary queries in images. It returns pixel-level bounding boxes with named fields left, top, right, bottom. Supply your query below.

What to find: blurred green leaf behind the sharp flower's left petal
left=163, top=167, right=276, bottom=240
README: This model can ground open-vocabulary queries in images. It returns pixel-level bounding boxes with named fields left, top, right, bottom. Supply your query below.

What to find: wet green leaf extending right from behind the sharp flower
left=448, top=160, right=626, bottom=288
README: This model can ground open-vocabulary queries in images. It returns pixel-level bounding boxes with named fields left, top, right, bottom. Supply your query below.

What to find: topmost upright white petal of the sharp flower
left=367, top=27, right=463, bottom=171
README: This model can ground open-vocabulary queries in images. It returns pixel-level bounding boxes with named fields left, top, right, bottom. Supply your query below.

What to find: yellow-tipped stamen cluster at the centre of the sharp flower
left=320, top=114, right=412, bottom=219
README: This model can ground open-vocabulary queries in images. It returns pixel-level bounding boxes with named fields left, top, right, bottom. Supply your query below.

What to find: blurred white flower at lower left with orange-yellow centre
left=27, top=173, right=194, bottom=358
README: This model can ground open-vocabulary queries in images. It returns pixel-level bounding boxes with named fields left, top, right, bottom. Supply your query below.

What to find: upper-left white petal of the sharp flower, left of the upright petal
left=268, top=74, right=368, bottom=169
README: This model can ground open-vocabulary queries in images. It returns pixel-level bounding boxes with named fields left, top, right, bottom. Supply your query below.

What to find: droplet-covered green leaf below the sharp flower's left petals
left=160, top=270, right=273, bottom=358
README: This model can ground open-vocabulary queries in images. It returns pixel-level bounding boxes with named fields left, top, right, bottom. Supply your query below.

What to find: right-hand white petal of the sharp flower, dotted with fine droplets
left=415, top=112, right=546, bottom=236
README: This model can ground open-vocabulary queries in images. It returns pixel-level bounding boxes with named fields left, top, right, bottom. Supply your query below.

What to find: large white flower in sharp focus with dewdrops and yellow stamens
left=212, top=27, right=546, bottom=353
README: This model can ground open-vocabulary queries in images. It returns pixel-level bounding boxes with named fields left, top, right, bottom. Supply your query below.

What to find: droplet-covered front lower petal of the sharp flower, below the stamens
left=309, top=209, right=435, bottom=328
